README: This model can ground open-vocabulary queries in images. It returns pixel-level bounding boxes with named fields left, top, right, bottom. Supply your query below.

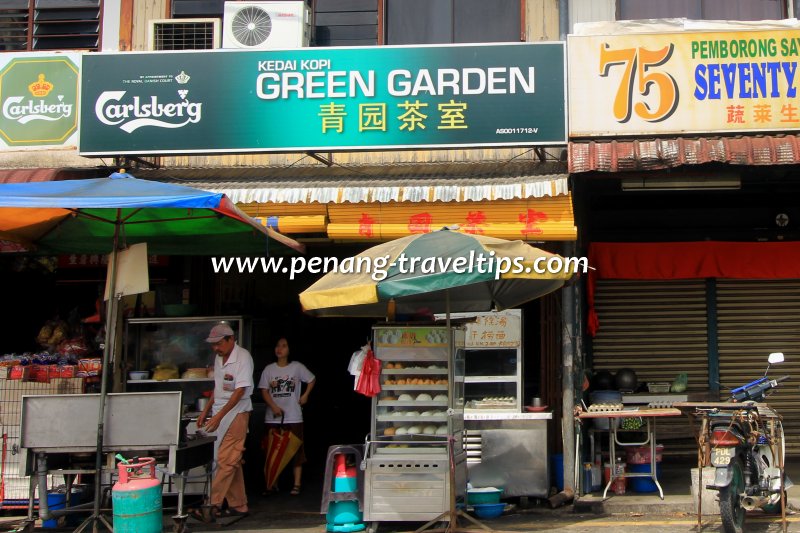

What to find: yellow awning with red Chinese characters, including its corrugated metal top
left=145, top=162, right=577, bottom=241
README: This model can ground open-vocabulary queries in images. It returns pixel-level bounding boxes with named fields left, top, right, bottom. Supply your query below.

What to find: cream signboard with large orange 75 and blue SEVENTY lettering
left=568, top=29, right=800, bottom=137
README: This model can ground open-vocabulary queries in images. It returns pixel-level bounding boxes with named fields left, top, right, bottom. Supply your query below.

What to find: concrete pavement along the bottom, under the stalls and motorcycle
left=0, top=460, right=800, bottom=533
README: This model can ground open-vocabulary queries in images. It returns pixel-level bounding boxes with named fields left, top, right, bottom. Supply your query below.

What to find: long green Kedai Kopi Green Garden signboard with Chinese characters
left=80, top=42, right=567, bottom=155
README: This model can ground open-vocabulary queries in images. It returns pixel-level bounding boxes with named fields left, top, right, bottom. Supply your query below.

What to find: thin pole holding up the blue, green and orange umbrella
left=74, top=209, right=122, bottom=533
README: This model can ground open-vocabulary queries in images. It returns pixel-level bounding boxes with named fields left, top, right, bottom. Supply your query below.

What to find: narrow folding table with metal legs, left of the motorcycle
left=578, top=407, right=682, bottom=500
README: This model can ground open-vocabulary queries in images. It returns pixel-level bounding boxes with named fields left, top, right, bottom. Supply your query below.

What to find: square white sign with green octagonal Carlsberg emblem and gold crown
left=0, top=52, right=81, bottom=150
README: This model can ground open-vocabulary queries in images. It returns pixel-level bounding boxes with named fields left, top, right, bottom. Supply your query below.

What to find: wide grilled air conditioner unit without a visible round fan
left=147, top=18, right=220, bottom=50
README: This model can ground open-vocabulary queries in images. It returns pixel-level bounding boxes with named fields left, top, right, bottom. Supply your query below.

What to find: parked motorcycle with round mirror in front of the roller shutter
left=697, top=353, right=792, bottom=533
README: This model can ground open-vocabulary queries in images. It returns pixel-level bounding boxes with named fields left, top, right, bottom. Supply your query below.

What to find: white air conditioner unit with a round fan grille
left=222, top=0, right=311, bottom=50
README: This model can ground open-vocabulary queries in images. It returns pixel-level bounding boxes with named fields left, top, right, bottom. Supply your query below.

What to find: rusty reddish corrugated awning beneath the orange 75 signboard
left=568, top=135, right=800, bottom=173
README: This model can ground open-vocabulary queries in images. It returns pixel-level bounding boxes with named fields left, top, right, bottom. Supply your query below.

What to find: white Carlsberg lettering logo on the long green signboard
left=94, top=91, right=203, bottom=133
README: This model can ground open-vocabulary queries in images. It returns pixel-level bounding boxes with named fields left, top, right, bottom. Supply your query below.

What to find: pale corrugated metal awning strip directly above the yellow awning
left=155, top=162, right=569, bottom=204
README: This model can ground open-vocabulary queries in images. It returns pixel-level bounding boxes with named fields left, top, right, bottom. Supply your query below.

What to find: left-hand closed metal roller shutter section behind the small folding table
left=592, top=280, right=708, bottom=455
